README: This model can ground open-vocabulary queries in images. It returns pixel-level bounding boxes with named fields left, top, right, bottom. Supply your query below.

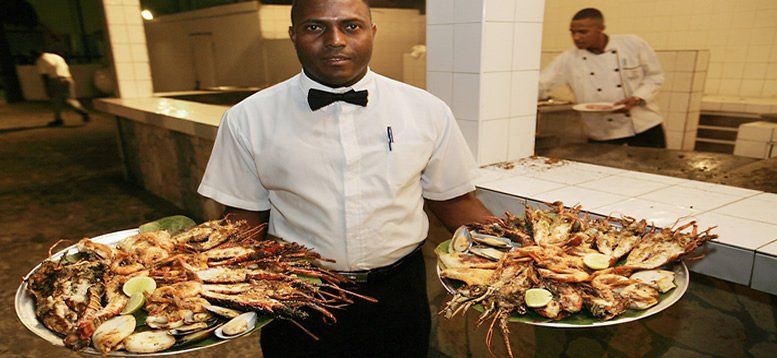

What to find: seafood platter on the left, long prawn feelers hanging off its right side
left=15, top=216, right=372, bottom=356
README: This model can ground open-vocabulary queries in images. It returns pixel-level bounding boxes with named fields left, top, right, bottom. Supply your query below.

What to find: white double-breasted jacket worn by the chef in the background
left=540, top=35, right=664, bottom=140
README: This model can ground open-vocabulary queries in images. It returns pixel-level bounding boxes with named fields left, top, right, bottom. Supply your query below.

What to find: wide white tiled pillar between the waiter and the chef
left=426, top=0, right=544, bottom=164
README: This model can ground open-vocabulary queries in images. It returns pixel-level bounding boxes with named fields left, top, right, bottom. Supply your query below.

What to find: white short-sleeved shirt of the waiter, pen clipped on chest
left=198, top=71, right=476, bottom=271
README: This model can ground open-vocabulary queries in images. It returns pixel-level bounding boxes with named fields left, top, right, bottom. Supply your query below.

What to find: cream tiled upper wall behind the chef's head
left=543, top=0, right=777, bottom=98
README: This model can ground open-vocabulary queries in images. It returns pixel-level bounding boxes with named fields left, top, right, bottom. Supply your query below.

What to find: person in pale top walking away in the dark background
left=31, top=51, right=89, bottom=127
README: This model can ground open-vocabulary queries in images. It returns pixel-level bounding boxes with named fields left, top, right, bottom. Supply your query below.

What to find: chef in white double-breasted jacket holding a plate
left=539, top=8, right=666, bottom=148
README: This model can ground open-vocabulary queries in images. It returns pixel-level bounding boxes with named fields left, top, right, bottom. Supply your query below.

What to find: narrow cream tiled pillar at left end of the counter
left=103, top=0, right=153, bottom=98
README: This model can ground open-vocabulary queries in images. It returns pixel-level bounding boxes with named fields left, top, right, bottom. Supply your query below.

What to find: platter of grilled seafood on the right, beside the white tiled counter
left=435, top=202, right=717, bottom=356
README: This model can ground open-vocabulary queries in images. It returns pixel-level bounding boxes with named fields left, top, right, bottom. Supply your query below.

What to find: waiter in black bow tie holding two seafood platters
left=198, top=0, right=491, bottom=357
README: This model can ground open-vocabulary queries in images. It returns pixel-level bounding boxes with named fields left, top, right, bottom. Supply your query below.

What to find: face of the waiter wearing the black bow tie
left=289, top=0, right=377, bottom=87
